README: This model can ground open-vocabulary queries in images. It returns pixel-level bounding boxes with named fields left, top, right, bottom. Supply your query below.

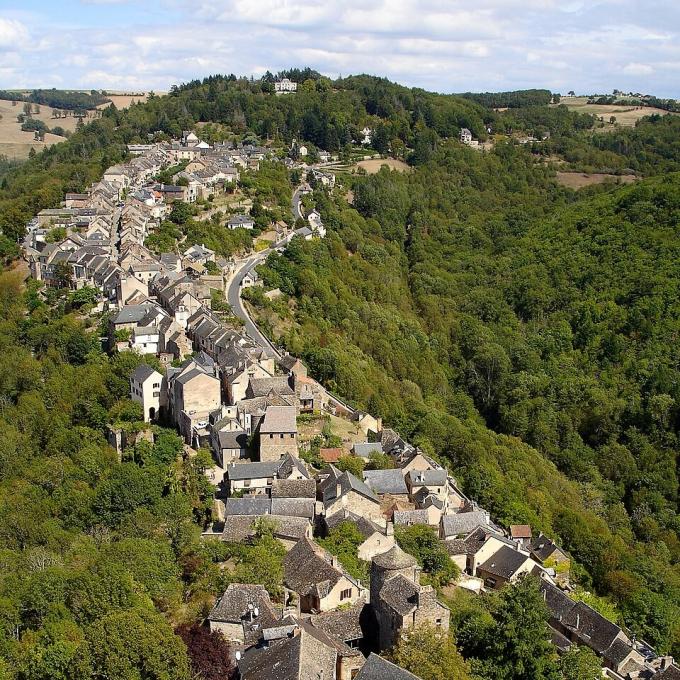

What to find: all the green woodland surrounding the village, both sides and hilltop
left=0, top=70, right=680, bottom=680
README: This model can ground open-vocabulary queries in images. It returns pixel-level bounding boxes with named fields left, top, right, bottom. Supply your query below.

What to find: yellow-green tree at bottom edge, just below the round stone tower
left=390, top=622, right=470, bottom=680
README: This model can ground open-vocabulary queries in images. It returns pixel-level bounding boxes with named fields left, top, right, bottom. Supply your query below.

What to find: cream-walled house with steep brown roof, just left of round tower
left=283, top=538, right=367, bottom=613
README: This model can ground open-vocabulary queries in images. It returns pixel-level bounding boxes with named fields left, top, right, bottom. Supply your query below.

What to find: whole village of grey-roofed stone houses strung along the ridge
left=18, top=117, right=680, bottom=680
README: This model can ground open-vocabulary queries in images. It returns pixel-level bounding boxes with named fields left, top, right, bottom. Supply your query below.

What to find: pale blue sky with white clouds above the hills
left=0, top=0, right=680, bottom=98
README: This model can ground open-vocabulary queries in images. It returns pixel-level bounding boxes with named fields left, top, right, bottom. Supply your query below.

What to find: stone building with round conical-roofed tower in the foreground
left=370, top=545, right=449, bottom=650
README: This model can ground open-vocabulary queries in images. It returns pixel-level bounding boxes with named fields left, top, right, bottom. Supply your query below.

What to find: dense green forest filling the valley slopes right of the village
left=251, top=139, right=680, bottom=654
